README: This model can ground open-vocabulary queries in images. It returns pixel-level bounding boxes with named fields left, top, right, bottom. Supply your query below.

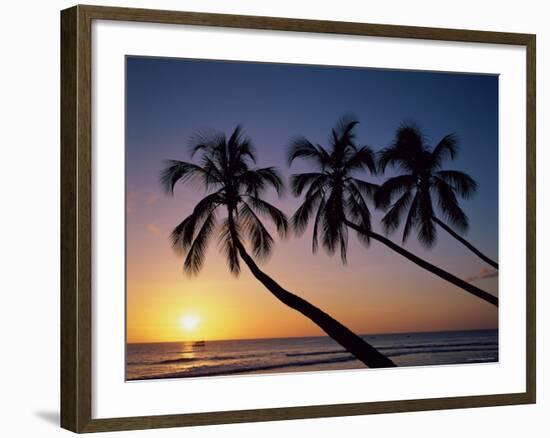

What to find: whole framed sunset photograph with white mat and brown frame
left=61, top=6, right=536, bottom=432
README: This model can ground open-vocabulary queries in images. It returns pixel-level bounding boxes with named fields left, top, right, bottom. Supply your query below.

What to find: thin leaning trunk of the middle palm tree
left=345, top=220, right=498, bottom=307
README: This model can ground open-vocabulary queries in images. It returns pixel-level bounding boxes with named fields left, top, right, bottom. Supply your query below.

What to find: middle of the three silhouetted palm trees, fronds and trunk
left=288, top=119, right=498, bottom=306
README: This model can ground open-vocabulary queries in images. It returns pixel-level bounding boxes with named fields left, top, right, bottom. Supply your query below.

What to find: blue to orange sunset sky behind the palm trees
left=126, top=57, right=498, bottom=342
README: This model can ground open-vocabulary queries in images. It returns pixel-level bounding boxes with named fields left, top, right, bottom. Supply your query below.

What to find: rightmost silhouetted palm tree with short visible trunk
left=376, top=125, right=498, bottom=269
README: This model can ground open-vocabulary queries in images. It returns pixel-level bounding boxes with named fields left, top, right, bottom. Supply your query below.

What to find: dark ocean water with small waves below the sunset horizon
left=126, top=330, right=498, bottom=380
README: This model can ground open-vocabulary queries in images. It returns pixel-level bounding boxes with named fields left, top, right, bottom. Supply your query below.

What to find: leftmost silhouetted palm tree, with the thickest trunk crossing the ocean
left=161, top=127, right=395, bottom=368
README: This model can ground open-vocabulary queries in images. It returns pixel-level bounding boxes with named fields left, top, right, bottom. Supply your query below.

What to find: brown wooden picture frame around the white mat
left=61, top=6, right=536, bottom=432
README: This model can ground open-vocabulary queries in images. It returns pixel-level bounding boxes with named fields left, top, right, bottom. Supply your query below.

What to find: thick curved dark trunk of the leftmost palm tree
left=237, top=242, right=395, bottom=368
